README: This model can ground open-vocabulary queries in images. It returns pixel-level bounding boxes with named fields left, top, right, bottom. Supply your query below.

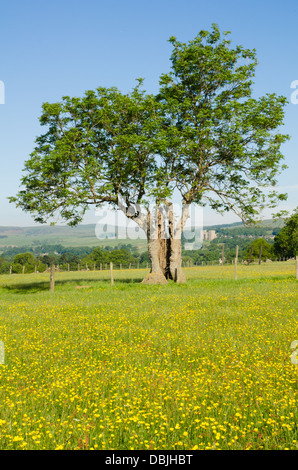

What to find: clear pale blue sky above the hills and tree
left=0, top=0, right=298, bottom=226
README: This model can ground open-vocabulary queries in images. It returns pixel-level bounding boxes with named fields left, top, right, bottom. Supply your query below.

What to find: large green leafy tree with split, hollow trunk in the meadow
left=10, top=25, right=288, bottom=283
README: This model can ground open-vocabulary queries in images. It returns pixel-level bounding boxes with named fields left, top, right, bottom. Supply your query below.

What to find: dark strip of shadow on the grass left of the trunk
left=1, top=277, right=143, bottom=294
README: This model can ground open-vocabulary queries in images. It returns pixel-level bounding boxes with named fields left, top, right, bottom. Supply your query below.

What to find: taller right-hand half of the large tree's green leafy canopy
left=158, top=25, right=288, bottom=222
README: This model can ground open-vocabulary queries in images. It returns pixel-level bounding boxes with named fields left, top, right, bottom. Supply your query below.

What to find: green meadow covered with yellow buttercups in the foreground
left=0, top=262, right=298, bottom=450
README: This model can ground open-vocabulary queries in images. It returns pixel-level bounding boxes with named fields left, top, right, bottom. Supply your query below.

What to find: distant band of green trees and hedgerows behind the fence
left=0, top=208, right=298, bottom=274
